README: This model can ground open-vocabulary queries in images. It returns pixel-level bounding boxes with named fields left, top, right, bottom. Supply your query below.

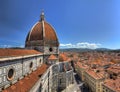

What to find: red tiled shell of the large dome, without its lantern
left=26, top=21, right=58, bottom=41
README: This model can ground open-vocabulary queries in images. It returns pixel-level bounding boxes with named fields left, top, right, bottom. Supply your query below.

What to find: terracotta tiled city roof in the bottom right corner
left=103, top=78, right=120, bottom=92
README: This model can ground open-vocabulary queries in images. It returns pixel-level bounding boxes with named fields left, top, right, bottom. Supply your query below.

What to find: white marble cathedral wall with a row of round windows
left=0, top=55, right=43, bottom=90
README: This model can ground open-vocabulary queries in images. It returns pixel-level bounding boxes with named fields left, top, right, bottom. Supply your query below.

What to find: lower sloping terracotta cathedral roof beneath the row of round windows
left=2, top=64, right=48, bottom=92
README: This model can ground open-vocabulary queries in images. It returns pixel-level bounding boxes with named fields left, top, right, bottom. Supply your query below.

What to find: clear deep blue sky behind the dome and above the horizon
left=0, top=0, right=120, bottom=49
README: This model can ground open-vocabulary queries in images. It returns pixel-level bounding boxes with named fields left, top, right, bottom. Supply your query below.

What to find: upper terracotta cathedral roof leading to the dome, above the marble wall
left=0, top=49, right=42, bottom=58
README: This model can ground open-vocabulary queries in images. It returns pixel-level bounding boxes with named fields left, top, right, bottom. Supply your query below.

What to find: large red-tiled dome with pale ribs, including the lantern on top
left=26, top=13, right=59, bottom=46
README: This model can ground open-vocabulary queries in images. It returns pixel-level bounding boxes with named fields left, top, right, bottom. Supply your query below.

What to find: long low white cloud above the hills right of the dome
left=60, top=42, right=101, bottom=49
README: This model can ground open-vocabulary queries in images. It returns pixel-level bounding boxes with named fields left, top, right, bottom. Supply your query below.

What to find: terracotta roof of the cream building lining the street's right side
left=86, top=69, right=104, bottom=79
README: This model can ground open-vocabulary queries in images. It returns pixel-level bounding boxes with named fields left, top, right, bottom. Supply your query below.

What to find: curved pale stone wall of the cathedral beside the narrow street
left=38, top=62, right=74, bottom=92
